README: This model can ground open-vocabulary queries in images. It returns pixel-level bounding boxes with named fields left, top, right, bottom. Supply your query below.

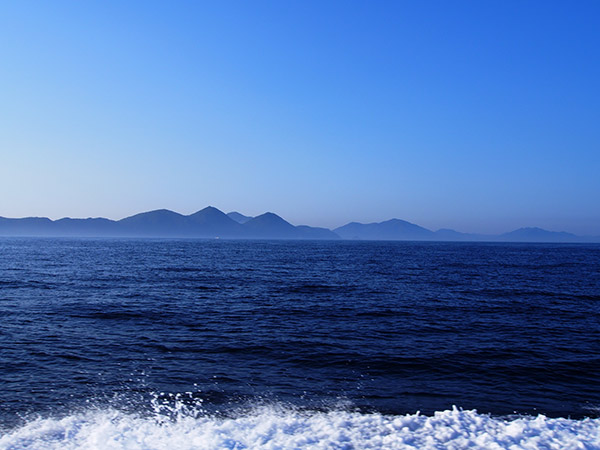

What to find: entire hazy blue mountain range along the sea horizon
left=0, top=206, right=600, bottom=242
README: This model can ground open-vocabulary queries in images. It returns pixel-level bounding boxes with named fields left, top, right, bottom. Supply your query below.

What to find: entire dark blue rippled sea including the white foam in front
left=0, top=238, right=600, bottom=449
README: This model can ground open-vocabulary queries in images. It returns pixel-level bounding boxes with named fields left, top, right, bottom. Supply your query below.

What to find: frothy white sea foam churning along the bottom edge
left=0, top=407, right=600, bottom=450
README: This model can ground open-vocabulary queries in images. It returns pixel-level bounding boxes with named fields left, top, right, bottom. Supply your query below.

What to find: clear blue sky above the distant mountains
left=0, top=0, right=600, bottom=235
